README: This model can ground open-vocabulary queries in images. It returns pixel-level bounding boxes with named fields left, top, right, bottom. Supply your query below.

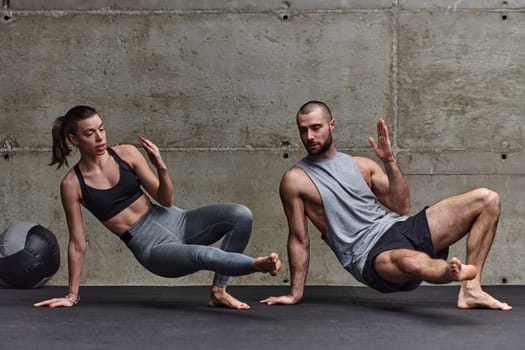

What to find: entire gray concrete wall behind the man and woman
left=0, top=0, right=525, bottom=285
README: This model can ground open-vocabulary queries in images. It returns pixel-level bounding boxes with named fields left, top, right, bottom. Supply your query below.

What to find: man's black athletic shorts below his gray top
left=363, top=207, right=448, bottom=293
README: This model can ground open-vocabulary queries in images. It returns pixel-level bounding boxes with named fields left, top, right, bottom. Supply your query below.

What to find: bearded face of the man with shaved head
left=297, top=108, right=335, bottom=156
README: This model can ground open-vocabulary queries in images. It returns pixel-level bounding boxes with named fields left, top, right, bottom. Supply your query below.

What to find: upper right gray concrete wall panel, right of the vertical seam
left=398, top=11, right=525, bottom=152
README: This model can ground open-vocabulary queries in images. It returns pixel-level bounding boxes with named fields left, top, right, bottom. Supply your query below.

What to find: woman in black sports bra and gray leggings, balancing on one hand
left=34, top=106, right=281, bottom=309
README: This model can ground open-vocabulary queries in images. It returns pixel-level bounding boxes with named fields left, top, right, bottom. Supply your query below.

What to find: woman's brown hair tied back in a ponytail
left=49, top=106, right=97, bottom=169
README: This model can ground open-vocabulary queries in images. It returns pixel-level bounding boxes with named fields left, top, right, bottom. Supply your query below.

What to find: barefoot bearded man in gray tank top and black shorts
left=261, top=101, right=512, bottom=310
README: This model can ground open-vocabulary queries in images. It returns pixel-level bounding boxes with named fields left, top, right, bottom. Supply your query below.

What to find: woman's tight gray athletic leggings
left=126, top=203, right=256, bottom=287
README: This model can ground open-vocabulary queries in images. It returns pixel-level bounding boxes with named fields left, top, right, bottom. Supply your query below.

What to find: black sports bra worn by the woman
left=74, top=148, right=143, bottom=222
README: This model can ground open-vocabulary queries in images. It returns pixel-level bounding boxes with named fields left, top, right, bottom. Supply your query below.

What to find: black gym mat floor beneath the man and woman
left=0, top=286, right=525, bottom=350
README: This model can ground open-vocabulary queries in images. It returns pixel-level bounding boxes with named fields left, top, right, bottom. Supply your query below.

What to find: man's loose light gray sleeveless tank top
left=298, top=152, right=408, bottom=283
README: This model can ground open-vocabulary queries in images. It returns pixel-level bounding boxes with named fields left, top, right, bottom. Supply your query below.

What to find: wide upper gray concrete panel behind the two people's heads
left=0, top=13, right=391, bottom=148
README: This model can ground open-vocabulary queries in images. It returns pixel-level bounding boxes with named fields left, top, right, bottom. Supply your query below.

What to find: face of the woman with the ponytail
left=69, top=114, right=107, bottom=156
